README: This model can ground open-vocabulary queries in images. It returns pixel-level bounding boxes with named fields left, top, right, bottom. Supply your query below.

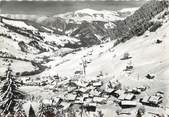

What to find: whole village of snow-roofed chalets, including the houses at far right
left=25, top=79, right=163, bottom=112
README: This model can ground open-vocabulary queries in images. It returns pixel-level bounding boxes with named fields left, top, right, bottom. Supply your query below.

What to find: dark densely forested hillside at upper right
left=111, top=0, right=169, bottom=41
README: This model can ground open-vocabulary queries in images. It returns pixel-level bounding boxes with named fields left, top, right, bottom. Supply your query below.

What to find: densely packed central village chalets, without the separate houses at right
left=30, top=80, right=121, bottom=112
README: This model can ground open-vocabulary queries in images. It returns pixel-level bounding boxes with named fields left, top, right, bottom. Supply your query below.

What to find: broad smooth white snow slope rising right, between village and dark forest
left=36, top=9, right=169, bottom=109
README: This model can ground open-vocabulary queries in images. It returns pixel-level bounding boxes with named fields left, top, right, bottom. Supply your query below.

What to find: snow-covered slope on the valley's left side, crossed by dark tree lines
left=0, top=17, right=80, bottom=76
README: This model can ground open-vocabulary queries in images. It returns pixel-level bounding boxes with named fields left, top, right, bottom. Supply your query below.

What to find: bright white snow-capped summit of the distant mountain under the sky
left=54, top=9, right=122, bottom=23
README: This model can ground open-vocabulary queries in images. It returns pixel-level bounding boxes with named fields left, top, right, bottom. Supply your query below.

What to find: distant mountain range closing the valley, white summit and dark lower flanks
left=0, top=9, right=125, bottom=46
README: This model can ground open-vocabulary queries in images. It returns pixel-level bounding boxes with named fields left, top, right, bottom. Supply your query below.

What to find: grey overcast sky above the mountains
left=0, top=0, right=146, bottom=16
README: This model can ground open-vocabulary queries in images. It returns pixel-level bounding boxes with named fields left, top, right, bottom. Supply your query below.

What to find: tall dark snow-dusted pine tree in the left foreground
left=0, top=68, right=25, bottom=114
